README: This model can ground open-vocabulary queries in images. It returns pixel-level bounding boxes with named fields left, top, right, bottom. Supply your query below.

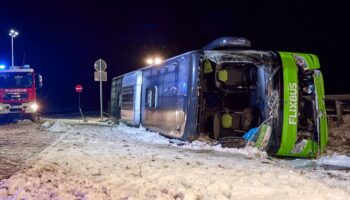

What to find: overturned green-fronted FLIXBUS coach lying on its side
left=110, top=37, right=328, bottom=157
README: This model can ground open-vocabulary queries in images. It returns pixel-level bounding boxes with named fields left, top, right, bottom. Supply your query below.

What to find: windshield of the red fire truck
left=0, top=72, right=33, bottom=88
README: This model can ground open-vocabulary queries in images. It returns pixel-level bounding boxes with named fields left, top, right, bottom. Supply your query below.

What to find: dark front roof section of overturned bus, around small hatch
left=141, top=52, right=194, bottom=138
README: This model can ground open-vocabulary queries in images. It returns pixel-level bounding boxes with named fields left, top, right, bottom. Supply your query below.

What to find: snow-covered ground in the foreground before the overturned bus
left=0, top=119, right=350, bottom=200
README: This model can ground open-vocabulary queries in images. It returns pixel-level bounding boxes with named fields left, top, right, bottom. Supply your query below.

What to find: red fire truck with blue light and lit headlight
left=0, top=65, right=42, bottom=121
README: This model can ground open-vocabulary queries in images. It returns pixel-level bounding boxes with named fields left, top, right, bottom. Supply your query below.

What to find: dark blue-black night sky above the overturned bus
left=0, top=0, right=350, bottom=110
